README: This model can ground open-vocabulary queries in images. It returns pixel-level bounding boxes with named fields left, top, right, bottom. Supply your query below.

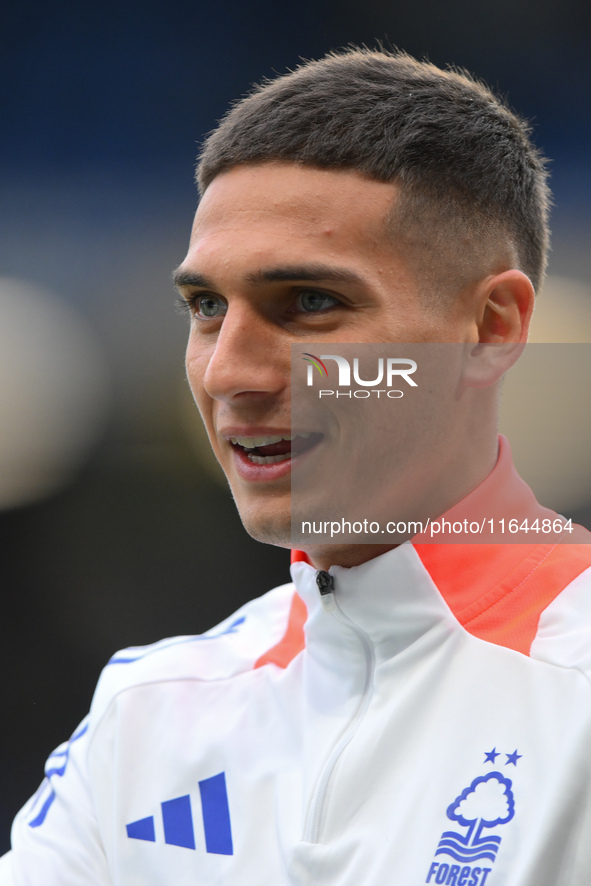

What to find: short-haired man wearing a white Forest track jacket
left=0, top=50, right=591, bottom=886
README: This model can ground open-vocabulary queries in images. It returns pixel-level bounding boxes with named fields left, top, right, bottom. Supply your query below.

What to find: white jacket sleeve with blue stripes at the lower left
left=0, top=720, right=112, bottom=886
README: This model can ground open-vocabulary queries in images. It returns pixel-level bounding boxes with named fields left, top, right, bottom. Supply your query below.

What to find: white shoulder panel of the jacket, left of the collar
left=92, top=584, right=297, bottom=720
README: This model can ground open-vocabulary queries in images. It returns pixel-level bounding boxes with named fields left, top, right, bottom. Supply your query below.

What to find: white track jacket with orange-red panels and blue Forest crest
left=0, top=448, right=591, bottom=886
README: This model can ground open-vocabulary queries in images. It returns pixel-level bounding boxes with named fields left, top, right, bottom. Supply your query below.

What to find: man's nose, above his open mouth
left=187, top=304, right=290, bottom=402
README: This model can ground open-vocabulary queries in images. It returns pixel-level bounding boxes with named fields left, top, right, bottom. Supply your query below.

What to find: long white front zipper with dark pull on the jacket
left=303, top=571, right=375, bottom=843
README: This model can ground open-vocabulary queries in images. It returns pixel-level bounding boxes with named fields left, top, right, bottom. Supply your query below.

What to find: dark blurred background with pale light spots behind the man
left=0, top=0, right=591, bottom=850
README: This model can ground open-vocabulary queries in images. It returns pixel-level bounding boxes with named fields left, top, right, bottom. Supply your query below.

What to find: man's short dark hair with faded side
left=197, top=48, right=550, bottom=290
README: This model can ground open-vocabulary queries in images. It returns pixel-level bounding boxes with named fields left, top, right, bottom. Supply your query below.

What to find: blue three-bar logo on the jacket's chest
left=126, top=772, right=234, bottom=855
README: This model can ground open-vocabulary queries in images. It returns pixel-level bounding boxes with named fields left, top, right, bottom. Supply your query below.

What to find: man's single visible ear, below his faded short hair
left=464, top=269, right=535, bottom=388
